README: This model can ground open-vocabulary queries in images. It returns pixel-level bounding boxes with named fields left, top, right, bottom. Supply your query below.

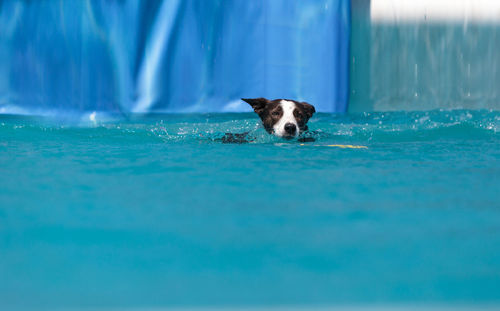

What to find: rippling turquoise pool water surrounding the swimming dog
left=0, top=111, right=500, bottom=309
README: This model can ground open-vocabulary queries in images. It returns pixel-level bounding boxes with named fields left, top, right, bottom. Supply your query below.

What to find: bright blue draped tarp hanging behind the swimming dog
left=0, top=0, right=350, bottom=114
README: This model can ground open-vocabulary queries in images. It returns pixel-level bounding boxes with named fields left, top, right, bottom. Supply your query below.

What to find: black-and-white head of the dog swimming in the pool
left=242, top=98, right=316, bottom=138
